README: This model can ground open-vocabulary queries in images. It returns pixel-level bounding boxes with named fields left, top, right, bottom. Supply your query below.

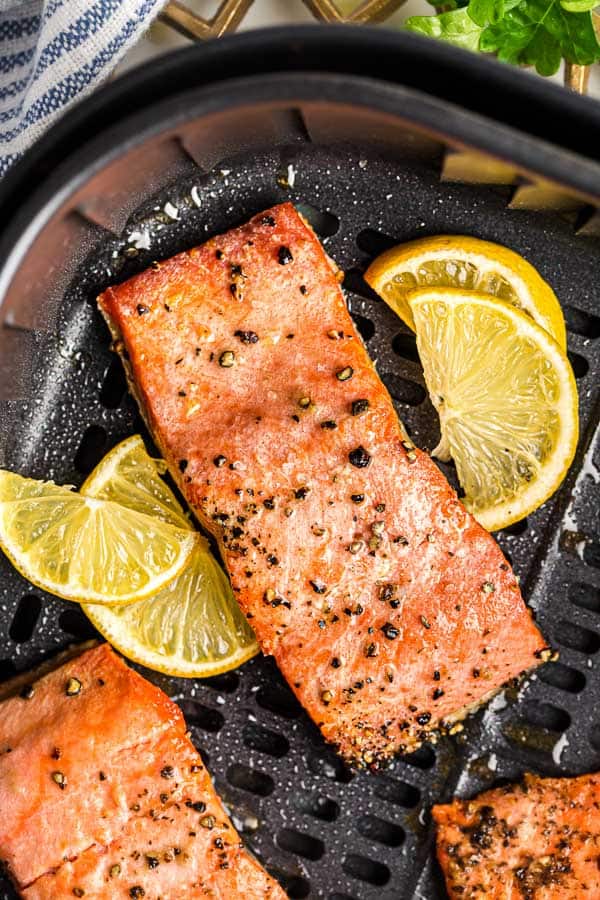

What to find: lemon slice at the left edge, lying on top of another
left=0, top=470, right=194, bottom=604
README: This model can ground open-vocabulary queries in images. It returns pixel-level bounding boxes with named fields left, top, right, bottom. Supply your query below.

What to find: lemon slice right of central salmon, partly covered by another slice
left=365, top=235, right=567, bottom=350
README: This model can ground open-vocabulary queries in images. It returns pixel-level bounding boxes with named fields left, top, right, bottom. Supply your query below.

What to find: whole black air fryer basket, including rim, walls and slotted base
left=0, top=29, right=600, bottom=900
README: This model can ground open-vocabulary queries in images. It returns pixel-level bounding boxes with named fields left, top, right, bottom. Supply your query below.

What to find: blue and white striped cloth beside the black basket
left=0, top=0, right=165, bottom=175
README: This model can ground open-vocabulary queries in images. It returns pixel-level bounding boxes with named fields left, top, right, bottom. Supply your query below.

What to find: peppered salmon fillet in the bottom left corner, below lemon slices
left=0, top=644, right=285, bottom=900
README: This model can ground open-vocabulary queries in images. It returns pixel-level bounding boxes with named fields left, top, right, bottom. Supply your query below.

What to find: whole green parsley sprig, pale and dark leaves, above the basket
left=405, top=0, right=600, bottom=75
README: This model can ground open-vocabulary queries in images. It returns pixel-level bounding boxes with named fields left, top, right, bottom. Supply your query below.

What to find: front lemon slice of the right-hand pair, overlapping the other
left=407, top=288, right=578, bottom=531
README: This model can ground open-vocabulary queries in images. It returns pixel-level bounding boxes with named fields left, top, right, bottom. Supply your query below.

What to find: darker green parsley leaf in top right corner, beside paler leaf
left=479, top=0, right=600, bottom=75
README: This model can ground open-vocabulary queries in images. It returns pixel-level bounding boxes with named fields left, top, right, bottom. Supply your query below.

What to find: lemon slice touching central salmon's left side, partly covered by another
left=81, top=435, right=258, bottom=678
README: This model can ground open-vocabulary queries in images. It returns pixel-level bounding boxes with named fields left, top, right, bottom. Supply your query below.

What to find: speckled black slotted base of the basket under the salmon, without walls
left=0, top=142, right=600, bottom=900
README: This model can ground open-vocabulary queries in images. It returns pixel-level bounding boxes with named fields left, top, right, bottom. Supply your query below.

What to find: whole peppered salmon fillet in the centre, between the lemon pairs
left=99, top=203, right=548, bottom=766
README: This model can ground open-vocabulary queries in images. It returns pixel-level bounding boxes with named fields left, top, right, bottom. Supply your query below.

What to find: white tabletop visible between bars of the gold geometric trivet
left=118, top=0, right=600, bottom=98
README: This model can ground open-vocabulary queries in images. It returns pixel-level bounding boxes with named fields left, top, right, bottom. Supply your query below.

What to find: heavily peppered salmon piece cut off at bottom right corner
left=433, top=774, right=600, bottom=900
